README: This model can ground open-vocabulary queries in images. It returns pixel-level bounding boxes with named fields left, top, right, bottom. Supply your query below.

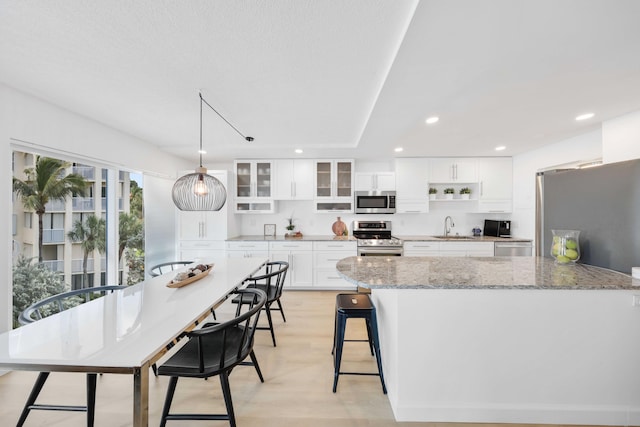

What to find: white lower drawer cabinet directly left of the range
left=313, top=241, right=358, bottom=290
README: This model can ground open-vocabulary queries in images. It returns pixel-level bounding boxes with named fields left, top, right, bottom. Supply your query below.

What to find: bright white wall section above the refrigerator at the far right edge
left=602, top=111, right=640, bottom=163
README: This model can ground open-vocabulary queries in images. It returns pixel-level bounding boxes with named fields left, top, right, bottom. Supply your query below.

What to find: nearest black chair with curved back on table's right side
left=158, top=289, right=267, bottom=427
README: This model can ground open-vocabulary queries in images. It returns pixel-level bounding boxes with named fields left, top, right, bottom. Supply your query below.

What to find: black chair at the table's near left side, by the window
left=16, top=285, right=126, bottom=427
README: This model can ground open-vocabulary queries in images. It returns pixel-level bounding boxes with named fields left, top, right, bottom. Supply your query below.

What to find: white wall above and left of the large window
left=0, top=84, right=192, bottom=331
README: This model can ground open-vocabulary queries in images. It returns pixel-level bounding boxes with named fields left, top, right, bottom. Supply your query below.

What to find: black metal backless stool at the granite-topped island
left=332, top=293, right=387, bottom=394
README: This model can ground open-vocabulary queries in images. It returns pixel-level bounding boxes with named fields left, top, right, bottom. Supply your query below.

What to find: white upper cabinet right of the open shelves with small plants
left=478, top=157, right=513, bottom=212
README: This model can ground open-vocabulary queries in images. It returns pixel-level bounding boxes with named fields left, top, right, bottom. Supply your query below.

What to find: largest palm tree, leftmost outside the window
left=13, top=156, right=87, bottom=262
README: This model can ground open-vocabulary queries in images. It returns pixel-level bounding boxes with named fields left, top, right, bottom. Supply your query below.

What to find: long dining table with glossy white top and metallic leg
left=0, top=258, right=267, bottom=427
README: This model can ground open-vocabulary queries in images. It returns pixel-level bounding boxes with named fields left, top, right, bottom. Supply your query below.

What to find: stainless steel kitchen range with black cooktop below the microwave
left=353, top=221, right=402, bottom=256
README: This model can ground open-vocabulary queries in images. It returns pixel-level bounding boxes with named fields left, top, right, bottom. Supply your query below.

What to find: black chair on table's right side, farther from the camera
left=232, top=261, right=289, bottom=347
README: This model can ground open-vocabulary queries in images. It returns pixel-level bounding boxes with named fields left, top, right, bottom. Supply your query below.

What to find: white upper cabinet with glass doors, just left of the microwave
left=314, top=160, right=354, bottom=212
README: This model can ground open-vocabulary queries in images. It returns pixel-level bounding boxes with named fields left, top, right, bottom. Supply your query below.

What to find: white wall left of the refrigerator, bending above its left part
left=511, top=130, right=602, bottom=246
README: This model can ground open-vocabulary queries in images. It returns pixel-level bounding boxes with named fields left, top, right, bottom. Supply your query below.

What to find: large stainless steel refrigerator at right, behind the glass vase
left=536, top=160, right=640, bottom=274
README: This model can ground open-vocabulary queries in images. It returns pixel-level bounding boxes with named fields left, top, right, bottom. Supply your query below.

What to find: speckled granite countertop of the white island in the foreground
left=336, top=256, right=640, bottom=290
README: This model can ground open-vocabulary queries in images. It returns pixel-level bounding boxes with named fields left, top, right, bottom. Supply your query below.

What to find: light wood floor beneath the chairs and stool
left=0, top=291, right=616, bottom=427
